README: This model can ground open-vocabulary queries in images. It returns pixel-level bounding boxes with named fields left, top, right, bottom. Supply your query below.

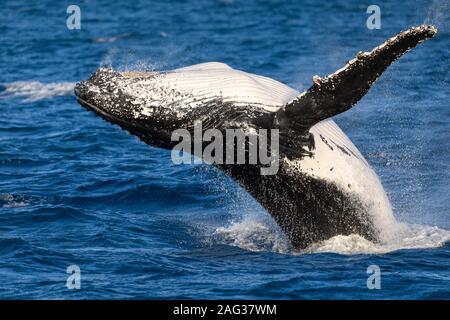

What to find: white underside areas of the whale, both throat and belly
left=121, top=62, right=396, bottom=241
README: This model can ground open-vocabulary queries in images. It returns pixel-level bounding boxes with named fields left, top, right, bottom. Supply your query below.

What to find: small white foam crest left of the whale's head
left=0, top=81, right=75, bottom=102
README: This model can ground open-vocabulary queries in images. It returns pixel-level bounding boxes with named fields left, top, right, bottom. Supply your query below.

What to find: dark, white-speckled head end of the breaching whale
left=74, top=68, right=186, bottom=148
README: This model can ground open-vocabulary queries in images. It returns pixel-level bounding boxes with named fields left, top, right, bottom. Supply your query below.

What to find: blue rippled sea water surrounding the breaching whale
left=0, top=0, right=450, bottom=299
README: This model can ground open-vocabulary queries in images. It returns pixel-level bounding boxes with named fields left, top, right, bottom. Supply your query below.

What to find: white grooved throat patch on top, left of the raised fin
left=123, top=62, right=298, bottom=112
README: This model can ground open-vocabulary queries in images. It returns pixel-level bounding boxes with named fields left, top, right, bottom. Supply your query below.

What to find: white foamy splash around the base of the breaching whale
left=215, top=217, right=450, bottom=255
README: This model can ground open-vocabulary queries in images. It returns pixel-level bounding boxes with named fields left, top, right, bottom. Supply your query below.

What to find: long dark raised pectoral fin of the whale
left=276, top=25, right=437, bottom=136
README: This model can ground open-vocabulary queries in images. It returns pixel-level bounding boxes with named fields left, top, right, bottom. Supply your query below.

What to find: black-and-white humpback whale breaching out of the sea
left=74, top=25, right=437, bottom=249
